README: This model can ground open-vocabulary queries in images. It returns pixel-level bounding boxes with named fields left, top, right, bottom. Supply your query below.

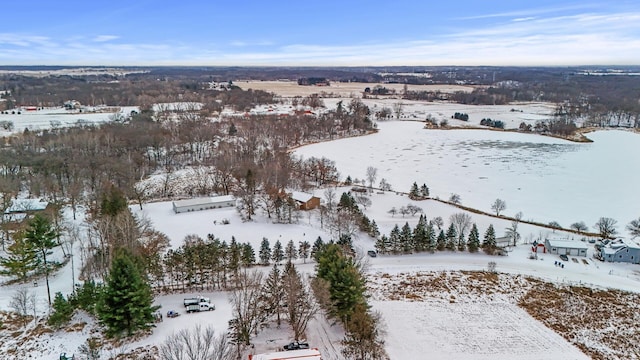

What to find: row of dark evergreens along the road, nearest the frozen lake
left=375, top=215, right=497, bottom=254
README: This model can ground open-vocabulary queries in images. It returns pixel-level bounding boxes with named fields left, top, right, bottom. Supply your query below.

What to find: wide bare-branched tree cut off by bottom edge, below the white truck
left=159, top=324, right=233, bottom=360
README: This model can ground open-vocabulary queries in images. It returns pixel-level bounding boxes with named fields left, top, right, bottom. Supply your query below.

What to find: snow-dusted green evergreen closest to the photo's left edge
left=0, top=232, right=38, bottom=282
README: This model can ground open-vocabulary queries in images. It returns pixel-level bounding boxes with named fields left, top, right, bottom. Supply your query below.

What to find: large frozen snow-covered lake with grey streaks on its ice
left=295, top=121, right=640, bottom=232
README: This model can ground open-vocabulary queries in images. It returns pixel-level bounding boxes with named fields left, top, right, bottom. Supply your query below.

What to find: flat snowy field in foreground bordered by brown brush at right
left=372, top=301, right=589, bottom=360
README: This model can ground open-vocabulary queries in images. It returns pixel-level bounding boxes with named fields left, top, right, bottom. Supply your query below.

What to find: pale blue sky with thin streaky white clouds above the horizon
left=0, top=0, right=640, bottom=66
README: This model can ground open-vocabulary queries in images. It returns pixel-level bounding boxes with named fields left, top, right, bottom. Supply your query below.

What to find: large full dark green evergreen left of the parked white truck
left=97, top=250, right=159, bottom=337
